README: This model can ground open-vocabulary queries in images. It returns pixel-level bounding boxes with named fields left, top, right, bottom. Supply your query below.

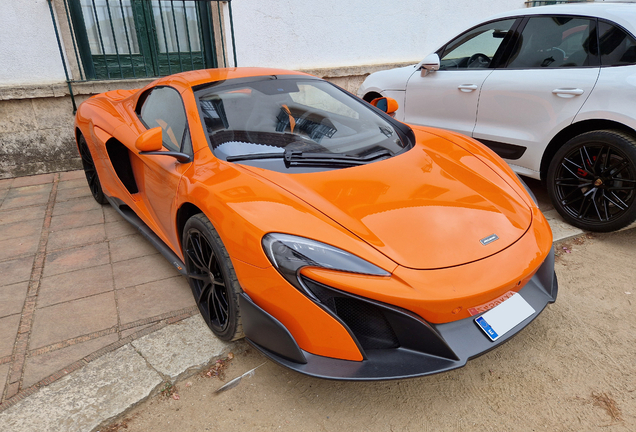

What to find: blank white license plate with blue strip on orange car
left=475, top=293, right=534, bottom=341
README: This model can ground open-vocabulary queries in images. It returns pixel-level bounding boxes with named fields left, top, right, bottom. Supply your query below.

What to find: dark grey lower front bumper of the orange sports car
left=239, top=251, right=558, bottom=381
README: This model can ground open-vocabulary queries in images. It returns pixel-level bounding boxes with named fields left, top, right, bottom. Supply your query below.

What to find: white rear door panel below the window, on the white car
left=473, top=68, right=599, bottom=171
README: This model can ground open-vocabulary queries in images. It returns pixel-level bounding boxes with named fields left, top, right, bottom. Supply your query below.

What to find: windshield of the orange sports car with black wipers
left=196, top=76, right=410, bottom=171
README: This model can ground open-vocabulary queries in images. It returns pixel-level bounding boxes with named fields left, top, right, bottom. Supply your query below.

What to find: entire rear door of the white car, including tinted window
left=473, top=16, right=599, bottom=178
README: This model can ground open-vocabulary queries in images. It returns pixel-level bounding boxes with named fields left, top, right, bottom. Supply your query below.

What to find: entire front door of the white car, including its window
left=404, top=19, right=515, bottom=135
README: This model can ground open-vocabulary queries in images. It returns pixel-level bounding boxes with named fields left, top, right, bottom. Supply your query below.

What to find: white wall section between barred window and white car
left=232, top=0, right=525, bottom=69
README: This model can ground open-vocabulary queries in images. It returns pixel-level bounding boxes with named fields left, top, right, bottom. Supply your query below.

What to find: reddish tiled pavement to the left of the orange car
left=0, top=171, right=196, bottom=401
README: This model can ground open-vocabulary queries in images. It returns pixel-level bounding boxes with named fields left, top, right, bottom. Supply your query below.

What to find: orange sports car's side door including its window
left=135, top=87, right=192, bottom=245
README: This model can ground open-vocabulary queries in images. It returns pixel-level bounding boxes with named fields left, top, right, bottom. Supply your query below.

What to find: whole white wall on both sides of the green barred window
left=0, top=0, right=524, bottom=86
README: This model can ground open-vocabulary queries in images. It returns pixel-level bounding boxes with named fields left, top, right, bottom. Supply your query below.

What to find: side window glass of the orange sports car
left=139, top=87, right=189, bottom=151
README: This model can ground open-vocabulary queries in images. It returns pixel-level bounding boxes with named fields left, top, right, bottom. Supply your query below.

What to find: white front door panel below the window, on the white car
left=404, top=69, right=493, bottom=136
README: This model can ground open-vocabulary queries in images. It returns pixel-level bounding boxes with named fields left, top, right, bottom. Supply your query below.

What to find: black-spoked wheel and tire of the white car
left=547, top=130, right=636, bottom=232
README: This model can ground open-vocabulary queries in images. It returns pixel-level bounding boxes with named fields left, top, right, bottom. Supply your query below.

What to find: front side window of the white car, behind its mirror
left=440, top=19, right=515, bottom=70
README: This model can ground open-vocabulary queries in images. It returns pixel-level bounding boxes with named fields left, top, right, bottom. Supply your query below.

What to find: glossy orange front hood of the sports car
left=246, top=131, right=532, bottom=269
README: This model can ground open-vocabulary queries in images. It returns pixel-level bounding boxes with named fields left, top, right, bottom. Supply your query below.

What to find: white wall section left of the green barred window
left=0, top=0, right=66, bottom=86
